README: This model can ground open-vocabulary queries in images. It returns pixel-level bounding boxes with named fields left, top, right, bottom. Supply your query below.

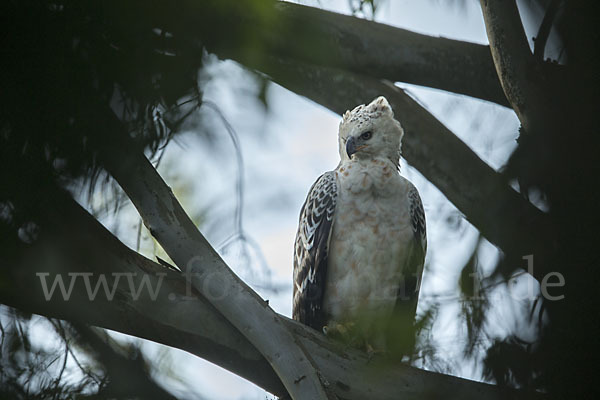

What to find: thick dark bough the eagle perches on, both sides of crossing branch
left=0, top=193, right=539, bottom=400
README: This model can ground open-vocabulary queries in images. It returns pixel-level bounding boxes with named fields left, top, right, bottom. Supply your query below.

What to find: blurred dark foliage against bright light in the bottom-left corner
left=0, top=307, right=178, bottom=399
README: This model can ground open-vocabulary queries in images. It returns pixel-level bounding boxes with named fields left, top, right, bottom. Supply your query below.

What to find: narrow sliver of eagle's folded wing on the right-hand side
left=394, top=184, right=427, bottom=354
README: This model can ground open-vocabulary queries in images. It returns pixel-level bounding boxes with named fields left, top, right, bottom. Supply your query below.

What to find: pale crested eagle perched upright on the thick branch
left=292, top=96, right=427, bottom=355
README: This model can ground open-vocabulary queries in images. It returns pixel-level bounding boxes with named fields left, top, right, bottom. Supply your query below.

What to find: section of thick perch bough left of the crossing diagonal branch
left=0, top=193, right=287, bottom=396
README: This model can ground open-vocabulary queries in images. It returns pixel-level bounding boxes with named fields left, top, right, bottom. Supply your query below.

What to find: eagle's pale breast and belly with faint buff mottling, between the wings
left=323, top=158, right=413, bottom=321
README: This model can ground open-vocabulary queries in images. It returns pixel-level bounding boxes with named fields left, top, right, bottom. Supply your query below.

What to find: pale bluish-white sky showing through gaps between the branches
left=69, top=0, right=544, bottom=400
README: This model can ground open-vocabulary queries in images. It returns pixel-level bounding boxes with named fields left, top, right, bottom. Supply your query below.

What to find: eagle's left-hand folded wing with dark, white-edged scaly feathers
left=293, top=171, right=337, bottom=330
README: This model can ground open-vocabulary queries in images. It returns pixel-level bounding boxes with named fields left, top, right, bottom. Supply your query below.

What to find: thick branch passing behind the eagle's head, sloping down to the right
left=266, top=61, right=552, bottom=280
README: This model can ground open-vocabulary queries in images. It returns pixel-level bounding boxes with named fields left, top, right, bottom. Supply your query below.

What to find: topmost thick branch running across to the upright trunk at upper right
left=104, top=0, right=509, bottom=106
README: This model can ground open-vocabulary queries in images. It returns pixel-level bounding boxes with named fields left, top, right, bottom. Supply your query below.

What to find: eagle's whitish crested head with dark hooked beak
left=339, top=96, right=404, bottom=165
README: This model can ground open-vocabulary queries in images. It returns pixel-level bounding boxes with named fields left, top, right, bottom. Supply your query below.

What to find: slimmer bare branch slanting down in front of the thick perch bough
left=98, top=113, right=333, bottom=399
